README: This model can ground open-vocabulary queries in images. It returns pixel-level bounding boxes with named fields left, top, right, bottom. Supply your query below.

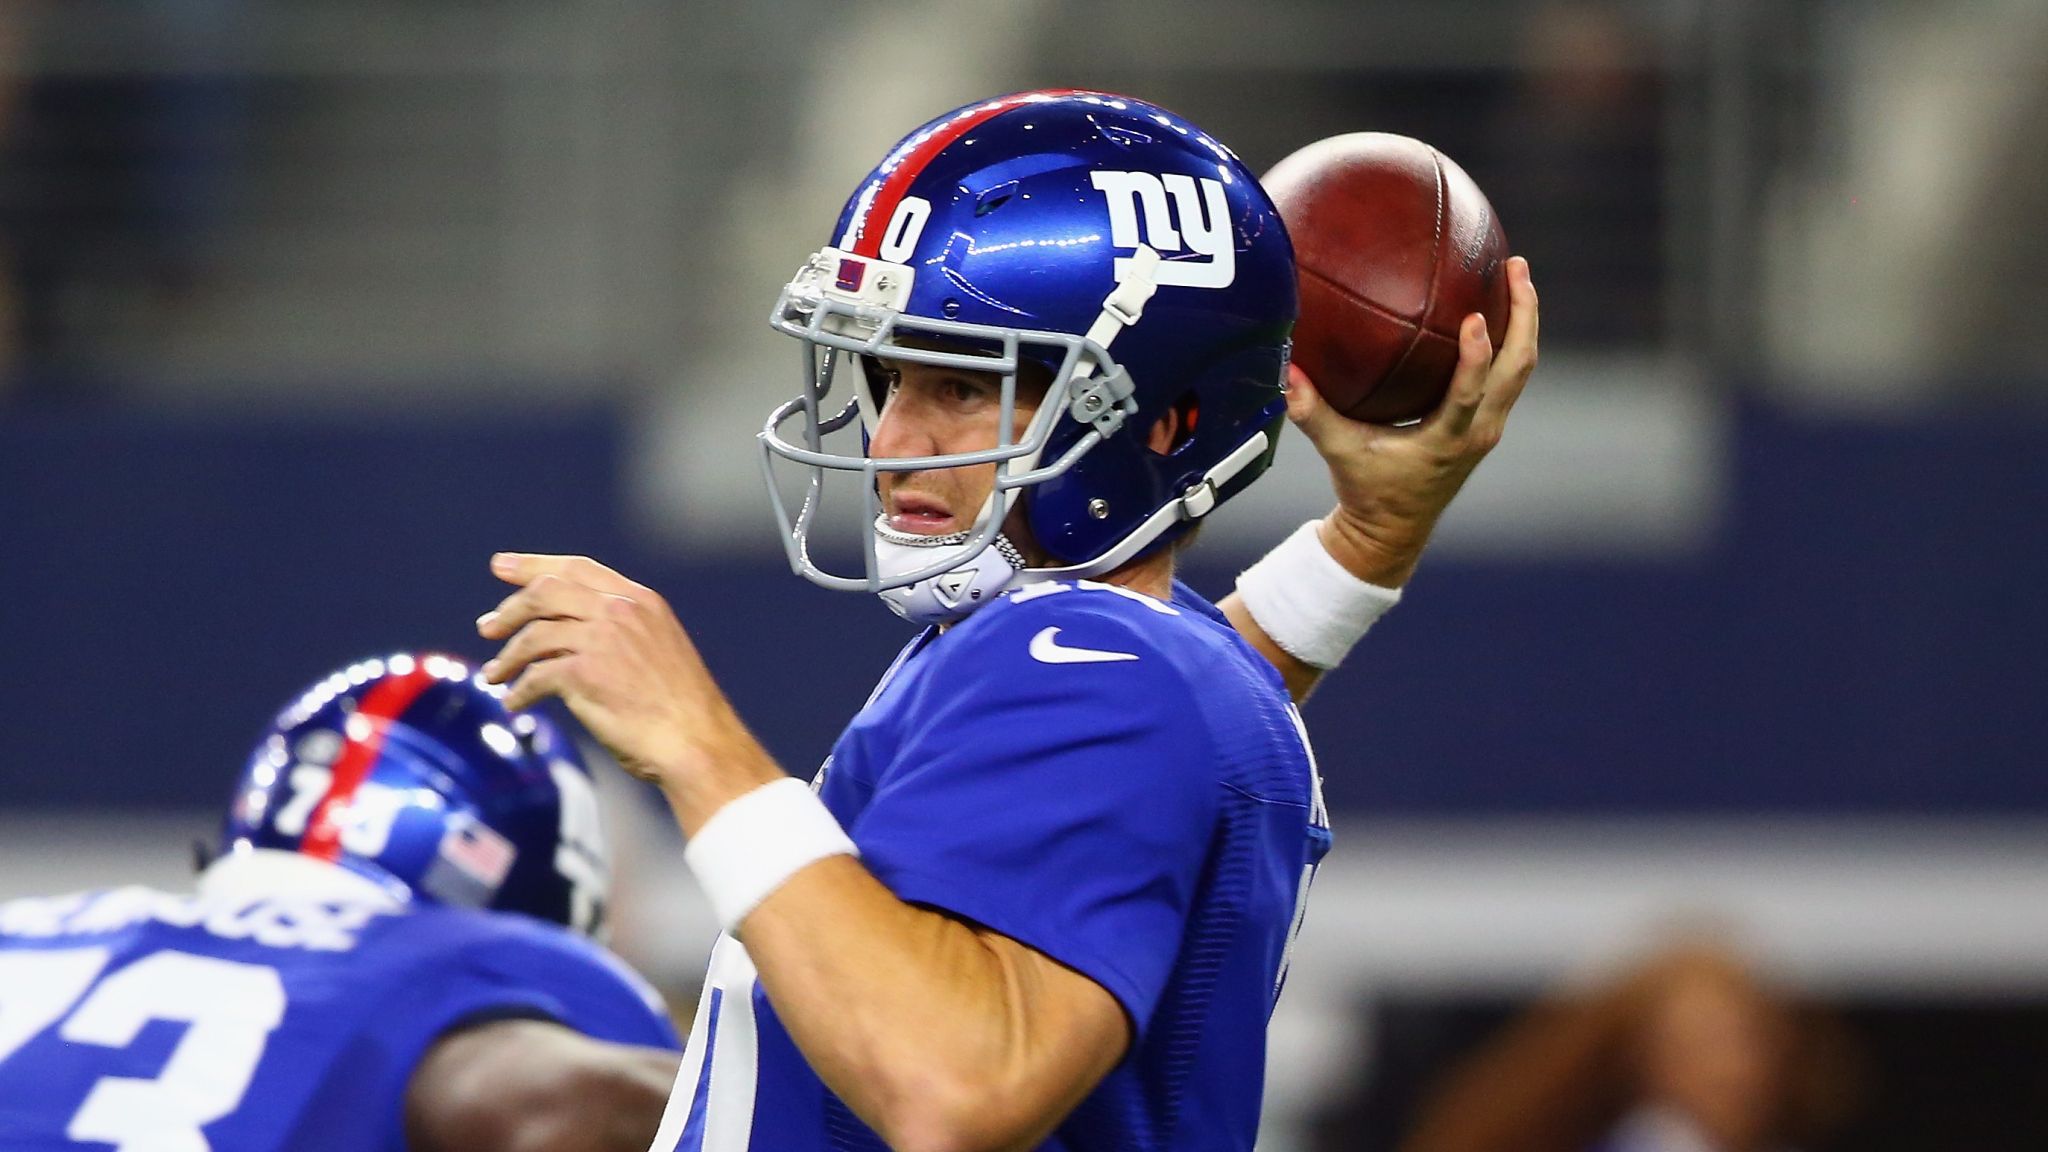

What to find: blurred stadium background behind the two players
left=0, top=0, right=2048, bottom=1150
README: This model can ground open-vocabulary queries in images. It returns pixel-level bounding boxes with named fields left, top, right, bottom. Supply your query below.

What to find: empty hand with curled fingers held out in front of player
left=477, top=551, right=780, bottom=816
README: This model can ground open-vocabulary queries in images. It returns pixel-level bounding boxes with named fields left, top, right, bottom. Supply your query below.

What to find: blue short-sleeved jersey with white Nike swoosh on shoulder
left=655, top=582, right=1329, bottom=1152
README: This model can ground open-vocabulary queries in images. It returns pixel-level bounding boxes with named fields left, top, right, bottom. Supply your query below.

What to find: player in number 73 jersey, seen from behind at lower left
left=0, top=656, right=678, bottom=1152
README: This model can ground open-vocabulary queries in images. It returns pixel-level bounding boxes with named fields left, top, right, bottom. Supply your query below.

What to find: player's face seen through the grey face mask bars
left=868, top=361, right=1047, bottom=535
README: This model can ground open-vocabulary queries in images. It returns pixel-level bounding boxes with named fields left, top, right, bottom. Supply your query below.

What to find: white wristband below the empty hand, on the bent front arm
left=682, top=777, right=860, bottom=933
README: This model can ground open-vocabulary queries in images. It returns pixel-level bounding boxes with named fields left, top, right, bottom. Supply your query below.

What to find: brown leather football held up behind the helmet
left=1264, top=131, right=1507, bottom=424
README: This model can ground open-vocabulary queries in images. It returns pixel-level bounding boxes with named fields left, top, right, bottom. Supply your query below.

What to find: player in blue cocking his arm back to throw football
left=477, top=92, right=1534, bottom=1152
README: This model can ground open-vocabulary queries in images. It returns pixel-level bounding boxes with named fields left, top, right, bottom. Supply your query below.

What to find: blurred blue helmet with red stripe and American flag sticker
left=221, top=654, right=608, bottom=933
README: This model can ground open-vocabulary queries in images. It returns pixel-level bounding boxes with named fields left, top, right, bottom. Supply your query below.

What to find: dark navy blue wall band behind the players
left=0, top=393, right=2048, bottom=816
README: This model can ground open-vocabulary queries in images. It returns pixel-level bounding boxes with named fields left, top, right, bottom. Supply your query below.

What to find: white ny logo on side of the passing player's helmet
left=1090, top=172, right=1237, bottom=287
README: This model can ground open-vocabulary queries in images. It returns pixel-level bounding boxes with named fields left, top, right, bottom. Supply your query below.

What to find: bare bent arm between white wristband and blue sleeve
left=741, top=857, right=1122, bottom=1152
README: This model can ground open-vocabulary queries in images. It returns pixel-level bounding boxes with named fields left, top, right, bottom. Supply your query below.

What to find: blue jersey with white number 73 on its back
left=0, top=860, right=676, bottom=1152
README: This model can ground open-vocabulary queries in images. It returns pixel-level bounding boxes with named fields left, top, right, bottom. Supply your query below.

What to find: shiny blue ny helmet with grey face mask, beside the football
left=760, top=90, right=1296, bottom=623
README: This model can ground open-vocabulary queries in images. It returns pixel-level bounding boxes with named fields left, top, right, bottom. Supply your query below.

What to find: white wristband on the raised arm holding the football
left=1237, top=521, right=1401, bottom=670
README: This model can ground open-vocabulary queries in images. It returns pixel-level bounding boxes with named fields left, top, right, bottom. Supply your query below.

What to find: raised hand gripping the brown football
left=1286, top=256, right=1536, bottom=588
